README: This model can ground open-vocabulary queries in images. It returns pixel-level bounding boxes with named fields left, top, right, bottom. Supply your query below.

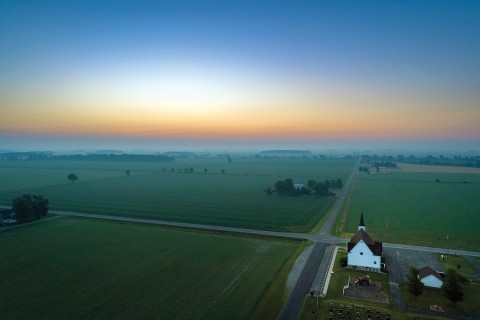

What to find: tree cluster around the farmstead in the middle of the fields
left=265, top=178, right=343, bottom=196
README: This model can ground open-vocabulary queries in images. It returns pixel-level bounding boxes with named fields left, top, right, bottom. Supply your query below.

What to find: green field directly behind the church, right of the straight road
left=337, top=171, right=480, bottom=251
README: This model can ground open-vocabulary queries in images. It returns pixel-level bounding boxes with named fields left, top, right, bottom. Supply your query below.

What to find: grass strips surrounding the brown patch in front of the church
left=299, top=251, right=443, bottom=320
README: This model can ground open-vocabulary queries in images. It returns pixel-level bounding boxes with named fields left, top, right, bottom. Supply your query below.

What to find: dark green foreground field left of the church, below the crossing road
left=0, top=218, right=301, bottom=319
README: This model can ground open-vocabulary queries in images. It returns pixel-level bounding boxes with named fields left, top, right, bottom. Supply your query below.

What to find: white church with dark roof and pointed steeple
left=347, top=211, right=383, bottom=272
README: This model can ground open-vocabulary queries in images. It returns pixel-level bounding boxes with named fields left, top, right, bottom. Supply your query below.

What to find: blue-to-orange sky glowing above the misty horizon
left=0, top=0, right=480, bottom=150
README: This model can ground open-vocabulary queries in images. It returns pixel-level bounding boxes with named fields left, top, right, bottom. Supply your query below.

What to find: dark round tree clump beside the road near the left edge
left=12, top=194, right=49, bottom=223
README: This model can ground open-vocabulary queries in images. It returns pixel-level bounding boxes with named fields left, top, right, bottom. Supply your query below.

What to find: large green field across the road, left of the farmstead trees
left=0, top=158, right=354, bottom=232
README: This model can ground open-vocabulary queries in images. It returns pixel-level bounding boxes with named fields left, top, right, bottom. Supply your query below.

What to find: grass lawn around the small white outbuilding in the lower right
left=400, top=282, right=480, bottom=317
